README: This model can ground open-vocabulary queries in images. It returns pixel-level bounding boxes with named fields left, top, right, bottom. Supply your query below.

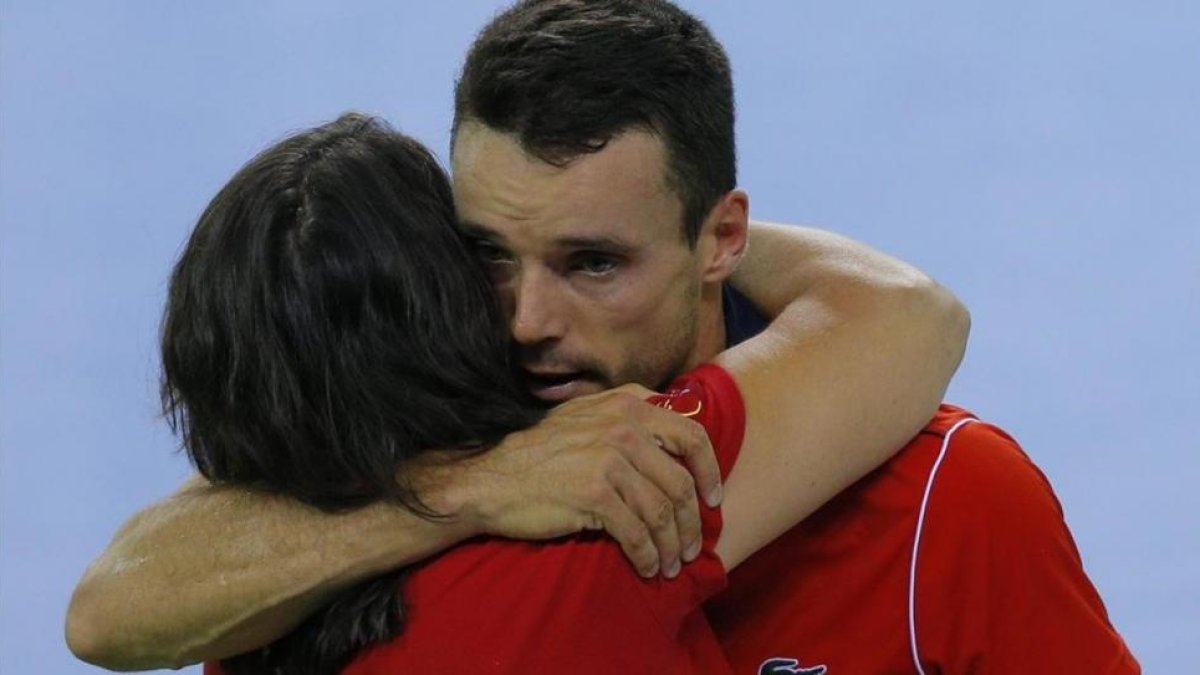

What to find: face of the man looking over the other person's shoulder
left=454, top=123, right=702, bottom=401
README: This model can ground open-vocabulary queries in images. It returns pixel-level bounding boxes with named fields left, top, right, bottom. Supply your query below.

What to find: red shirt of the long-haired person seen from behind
left=205, top=365, right=745, bottom=675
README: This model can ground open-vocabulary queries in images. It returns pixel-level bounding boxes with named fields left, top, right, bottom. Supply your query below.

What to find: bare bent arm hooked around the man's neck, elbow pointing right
left=715, top=223, right=970, bottom=569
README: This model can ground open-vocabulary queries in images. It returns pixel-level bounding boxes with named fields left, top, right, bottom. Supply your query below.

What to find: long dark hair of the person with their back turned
left=162, top=113, right=541, bottom=675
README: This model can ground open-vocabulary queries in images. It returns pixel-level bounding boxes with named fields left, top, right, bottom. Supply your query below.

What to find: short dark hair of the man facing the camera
left=454, top=0, right=737, bottom=245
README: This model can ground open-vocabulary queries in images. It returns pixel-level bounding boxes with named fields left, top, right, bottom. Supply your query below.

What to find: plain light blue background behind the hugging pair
left=0, top=0, right=1200, bottom=675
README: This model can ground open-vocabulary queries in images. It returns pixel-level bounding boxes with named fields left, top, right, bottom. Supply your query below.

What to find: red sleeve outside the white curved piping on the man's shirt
left=916, top=423, right=1140, bottom=674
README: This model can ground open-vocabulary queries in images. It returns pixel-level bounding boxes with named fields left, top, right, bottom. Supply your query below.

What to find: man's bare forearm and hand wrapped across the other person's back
left=66, top=392, right=719, bottom=670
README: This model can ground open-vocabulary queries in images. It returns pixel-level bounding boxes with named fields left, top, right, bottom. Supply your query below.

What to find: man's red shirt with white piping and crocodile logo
left=707, top=405, right=1140, bottom=675
